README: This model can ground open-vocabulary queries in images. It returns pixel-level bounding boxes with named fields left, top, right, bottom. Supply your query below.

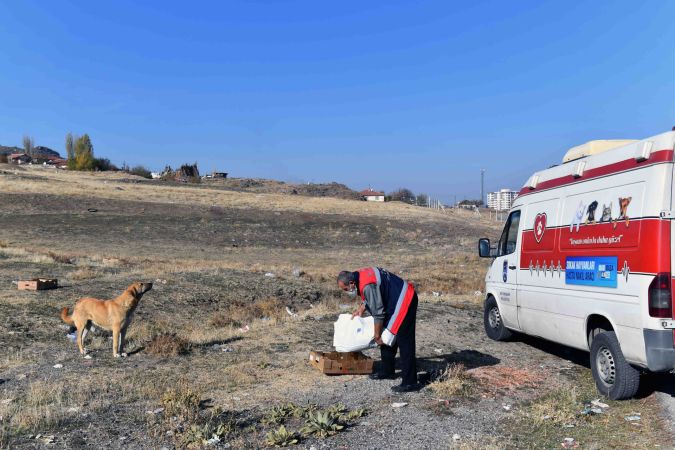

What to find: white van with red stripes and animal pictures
left=479, top=131, right=675, bottom=399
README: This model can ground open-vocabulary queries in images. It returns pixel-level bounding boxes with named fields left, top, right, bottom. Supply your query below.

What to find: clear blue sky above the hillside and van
left=0, top=0, right=675, bottom=201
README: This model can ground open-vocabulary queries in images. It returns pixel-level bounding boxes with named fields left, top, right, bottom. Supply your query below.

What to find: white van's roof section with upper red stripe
left=514, top=131, right=675, bottom=201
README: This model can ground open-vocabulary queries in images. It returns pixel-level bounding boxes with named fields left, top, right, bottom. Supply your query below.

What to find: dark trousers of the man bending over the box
left=380, top=293, right=417, bottom=385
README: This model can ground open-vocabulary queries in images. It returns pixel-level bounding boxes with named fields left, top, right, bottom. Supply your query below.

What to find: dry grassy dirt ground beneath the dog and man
left=0, top=165, right=673, bottom=449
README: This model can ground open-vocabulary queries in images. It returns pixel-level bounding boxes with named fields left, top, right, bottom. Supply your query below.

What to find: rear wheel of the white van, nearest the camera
left=591, top=331, right=640, bottom=400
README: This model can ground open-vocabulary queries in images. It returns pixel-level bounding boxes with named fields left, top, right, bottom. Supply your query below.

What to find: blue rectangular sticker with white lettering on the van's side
left=565, top=256, right=618, bottom=288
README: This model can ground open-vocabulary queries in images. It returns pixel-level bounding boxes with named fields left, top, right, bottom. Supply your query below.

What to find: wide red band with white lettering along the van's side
left=520, top=219, right=670, bottom=273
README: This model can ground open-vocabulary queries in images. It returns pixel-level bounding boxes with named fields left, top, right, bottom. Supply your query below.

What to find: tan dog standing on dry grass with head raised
left=61, top=282, right=152, bottom=358
